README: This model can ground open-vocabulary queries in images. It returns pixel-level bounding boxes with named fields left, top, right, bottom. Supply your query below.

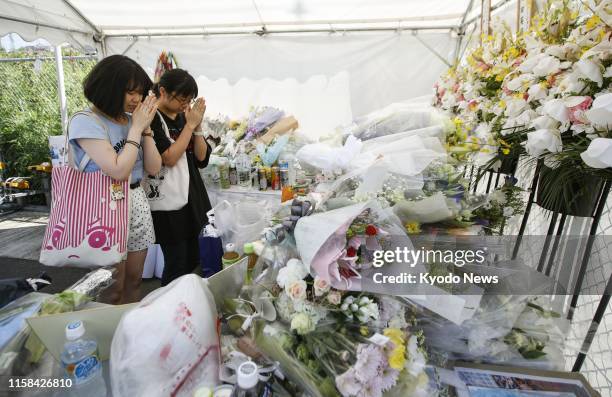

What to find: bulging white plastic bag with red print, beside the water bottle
left=110, top=274, right=220, bottom=397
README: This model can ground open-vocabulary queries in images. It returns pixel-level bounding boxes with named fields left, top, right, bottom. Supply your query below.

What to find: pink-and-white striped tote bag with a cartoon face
left=40, top=110, right=130, bottom=268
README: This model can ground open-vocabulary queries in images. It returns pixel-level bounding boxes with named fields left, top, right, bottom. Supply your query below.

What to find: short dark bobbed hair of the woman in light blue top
left=83, top=55, right=153, bottom=117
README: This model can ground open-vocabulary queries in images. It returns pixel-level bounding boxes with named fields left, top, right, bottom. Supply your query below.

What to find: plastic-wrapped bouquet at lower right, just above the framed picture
left=418, top=295, right=577, bottom=370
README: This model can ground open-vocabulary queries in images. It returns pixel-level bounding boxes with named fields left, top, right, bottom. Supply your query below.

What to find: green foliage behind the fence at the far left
left=0, top=51, right=96, bottom=178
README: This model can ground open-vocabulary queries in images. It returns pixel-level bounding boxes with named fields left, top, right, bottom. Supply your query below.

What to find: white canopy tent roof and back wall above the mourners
left=0, top=0, right=511, bottom=135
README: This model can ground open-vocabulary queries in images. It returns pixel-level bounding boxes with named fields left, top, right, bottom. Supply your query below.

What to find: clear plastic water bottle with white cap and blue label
left=61, top=321, right=106, bottom=397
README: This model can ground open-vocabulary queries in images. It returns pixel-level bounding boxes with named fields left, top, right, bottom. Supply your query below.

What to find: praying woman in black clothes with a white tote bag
left=151, top=69, right=211, bottom=285
